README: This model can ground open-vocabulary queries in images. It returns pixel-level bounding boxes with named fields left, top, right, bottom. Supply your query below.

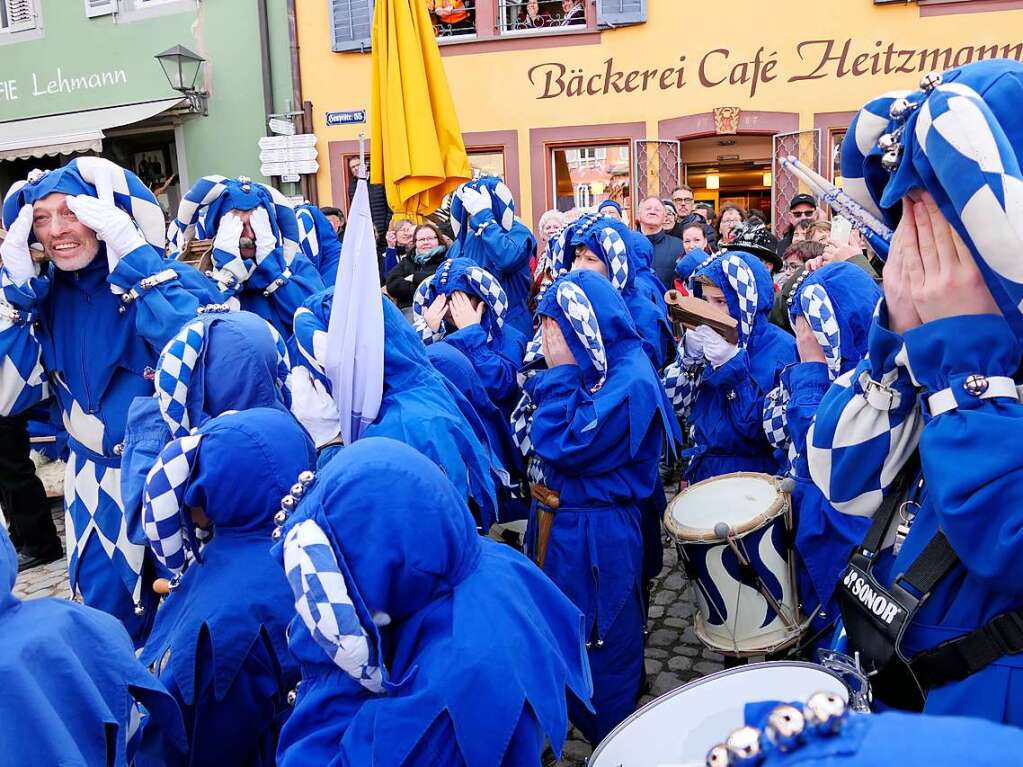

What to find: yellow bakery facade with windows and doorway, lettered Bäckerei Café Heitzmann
left=296, top=0, right=1023, bottom=233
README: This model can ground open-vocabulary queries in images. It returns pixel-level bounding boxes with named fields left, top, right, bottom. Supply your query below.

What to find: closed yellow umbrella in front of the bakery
left=370, top=0, right=473, bottom=221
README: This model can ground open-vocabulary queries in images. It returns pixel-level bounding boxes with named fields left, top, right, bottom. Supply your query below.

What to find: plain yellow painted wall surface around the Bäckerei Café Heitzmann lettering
left=296, top=0, right=1023, bottom=220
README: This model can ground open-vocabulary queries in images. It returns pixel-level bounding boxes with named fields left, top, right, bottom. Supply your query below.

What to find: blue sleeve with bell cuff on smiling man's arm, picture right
left=107, top=245, right=208, bottom=350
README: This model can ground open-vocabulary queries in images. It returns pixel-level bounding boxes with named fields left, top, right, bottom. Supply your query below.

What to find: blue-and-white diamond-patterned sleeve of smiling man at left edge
left=0, top=268, right=49, bottom=415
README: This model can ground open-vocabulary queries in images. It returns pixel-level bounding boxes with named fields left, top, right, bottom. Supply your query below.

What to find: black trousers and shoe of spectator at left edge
left=0, top=414, right=63, bottom=573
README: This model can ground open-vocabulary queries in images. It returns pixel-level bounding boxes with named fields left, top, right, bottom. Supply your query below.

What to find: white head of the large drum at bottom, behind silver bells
left=587, top=662, right=849, bottom=767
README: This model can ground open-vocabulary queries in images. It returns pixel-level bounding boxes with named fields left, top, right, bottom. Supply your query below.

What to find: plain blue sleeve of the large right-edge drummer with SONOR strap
left=905, top=315, right=1023, bottom=594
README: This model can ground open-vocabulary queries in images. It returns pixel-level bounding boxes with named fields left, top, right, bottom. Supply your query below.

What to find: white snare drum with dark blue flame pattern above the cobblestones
left=664, top=471, right=805, bottom=658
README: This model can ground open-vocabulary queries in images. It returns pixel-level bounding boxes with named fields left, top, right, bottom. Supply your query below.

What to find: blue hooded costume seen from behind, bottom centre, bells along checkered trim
left=274, top=438, right=590, bottom=767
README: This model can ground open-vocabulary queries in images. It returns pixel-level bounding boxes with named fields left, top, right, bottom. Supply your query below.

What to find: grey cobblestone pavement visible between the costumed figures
left=14, top=494, right=723, bottom=767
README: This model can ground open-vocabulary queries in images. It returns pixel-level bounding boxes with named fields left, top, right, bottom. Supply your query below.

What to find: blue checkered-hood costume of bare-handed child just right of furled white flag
left=412, top=258, right=527, bottom=414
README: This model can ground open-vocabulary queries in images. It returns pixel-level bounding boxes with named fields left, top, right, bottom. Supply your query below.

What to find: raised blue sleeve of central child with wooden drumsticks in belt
left=527, top=365, right=632, bottom=476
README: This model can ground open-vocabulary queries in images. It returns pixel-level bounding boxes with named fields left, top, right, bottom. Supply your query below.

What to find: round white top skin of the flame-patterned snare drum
left=665, top=473, right=780, bottom=540
